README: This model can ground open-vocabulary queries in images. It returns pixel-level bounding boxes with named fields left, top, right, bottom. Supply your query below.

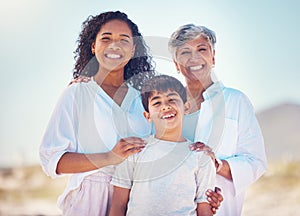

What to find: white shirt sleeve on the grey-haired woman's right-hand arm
left=225, top=94, right=267, bottom=194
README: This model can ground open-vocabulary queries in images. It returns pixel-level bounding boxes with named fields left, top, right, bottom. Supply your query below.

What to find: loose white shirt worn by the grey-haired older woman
left=183, top=82, right=267, bottom=216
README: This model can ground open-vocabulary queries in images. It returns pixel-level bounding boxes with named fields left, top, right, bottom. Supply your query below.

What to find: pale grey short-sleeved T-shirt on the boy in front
left=112, top=136, right=216, bottom=216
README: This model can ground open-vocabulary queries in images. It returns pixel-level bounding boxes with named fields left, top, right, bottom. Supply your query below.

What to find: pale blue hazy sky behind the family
left=0, top=0, right=300, bottom=166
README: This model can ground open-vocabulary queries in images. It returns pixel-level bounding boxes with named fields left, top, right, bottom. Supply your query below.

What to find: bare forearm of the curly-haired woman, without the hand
left=56, top=152, right=119, bottom=174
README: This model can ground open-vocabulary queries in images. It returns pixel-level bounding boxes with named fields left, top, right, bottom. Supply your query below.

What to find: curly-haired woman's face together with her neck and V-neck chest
left=91, top=20, right=135, bottom=105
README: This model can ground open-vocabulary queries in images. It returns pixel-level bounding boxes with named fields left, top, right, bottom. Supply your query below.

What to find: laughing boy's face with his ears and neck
left=144, top=90, right=189, bottom=142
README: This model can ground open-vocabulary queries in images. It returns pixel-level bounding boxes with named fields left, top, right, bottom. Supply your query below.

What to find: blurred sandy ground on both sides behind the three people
left=0, top=163, right=300, bottom=216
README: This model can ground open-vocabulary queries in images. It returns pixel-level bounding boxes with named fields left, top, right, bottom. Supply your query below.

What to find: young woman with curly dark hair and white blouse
left=40, top=11, right=154, bottom=216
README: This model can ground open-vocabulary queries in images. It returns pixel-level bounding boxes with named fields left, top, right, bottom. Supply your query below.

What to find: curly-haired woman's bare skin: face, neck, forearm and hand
left=56, top=20, right=146, bottom=176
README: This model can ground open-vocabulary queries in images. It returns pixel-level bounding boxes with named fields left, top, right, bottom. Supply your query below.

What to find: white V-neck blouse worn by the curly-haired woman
left=40, top=80, right=151, bottom=206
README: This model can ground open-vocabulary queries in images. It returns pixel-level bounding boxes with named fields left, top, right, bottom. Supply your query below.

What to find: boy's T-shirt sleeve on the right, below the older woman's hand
left=196, top=152, right=216, bottom=203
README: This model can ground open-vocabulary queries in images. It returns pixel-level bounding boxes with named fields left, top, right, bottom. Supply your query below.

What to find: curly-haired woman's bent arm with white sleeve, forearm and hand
left=39, top=84, right=144, bottom=178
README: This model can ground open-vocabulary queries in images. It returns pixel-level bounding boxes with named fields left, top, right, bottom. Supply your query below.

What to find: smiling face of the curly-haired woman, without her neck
left=92, top=20, right=135, bottom=72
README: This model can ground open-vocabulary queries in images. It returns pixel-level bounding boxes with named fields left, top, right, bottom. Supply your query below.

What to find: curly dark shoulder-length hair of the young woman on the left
left=73, top=11, right=155, bottom=90
